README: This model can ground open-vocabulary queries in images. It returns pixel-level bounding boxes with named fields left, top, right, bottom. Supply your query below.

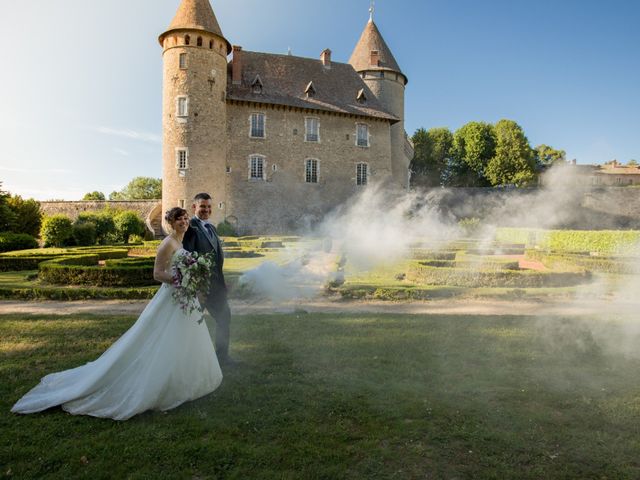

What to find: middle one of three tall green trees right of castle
left=446, top=122, right=496, bottom=187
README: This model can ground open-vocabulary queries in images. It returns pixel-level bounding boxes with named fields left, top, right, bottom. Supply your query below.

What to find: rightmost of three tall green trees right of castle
left=486, top=120, right=535, bottom=186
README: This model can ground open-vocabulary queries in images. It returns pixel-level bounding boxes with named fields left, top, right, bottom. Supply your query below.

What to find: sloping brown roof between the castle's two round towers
left=227, top=50, right=399, bottom=123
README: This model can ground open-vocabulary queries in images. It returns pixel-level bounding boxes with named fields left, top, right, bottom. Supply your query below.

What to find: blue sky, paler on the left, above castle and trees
left=0, top=0, right=640, bottom=200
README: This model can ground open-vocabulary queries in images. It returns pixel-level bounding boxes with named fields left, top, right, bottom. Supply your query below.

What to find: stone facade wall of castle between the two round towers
left=225, top=105, right=391, bottom=233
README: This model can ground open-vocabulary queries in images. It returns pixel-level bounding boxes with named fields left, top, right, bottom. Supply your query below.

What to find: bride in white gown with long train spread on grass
left=11, top=207, right=222, bottom=420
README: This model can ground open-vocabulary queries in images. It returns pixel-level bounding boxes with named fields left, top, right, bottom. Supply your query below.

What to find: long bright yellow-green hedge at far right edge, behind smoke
left=496, top=228, right=640, bottom=255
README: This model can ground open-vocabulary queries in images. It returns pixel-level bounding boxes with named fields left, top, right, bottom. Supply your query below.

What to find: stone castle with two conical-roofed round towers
left=159, top=0, right=413, bottom=234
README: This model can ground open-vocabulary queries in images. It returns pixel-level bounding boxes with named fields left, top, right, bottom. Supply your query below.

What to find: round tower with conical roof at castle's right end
left=349, top=11, right=411, bottom=188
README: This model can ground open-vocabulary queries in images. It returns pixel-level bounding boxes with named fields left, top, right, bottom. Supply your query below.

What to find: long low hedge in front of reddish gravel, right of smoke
left=407, top=262, right=591, bottom=288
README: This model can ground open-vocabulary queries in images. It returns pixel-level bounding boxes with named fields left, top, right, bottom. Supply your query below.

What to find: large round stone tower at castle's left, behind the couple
left=158, top=0, right=231, bottom=228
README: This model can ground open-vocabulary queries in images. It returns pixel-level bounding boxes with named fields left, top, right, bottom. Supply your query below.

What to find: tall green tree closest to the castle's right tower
left=411, top=127, right=453, bottom=187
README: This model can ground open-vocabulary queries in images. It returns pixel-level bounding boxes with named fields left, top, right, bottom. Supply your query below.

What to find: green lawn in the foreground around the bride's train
left=0, top=313, right=640, bottom=479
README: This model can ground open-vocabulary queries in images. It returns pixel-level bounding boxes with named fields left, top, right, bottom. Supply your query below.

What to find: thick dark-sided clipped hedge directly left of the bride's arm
left=38, top=255, right=157, bottom=287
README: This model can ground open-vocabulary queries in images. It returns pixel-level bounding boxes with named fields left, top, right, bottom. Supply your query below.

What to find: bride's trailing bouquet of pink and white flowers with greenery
left=172, top=251, right=216, bottom=323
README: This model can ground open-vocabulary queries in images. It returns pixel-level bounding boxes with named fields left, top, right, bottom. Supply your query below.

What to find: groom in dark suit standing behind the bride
left=182, top=193, right=235, bottom=365
